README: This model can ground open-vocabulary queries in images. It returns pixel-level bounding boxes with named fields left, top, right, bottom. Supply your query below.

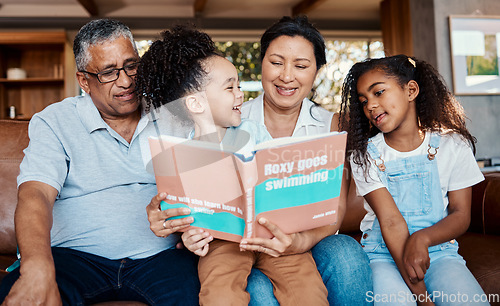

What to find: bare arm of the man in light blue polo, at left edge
left=3, top=181, right=62, bottom=305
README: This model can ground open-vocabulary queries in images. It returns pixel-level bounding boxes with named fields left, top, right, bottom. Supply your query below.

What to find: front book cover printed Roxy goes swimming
left=249, top=133, right=347, bottom=238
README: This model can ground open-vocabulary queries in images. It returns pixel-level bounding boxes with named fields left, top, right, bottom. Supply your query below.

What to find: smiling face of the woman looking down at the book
left=262, top=35, right=317, bottom=110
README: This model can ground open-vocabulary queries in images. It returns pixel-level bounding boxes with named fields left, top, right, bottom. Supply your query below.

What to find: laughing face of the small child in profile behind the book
left=204, top=56, right=243, bottom=128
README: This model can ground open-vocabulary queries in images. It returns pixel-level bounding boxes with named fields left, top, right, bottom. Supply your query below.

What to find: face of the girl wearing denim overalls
left=357, top=70, right=418, bottom=134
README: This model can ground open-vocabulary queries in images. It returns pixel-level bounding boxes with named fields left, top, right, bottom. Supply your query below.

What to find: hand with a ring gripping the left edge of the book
left=146, top=192, right=194, bottom=238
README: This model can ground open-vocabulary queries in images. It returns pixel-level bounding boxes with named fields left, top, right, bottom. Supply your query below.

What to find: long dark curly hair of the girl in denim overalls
left=340, top=55, right=476, bottom=169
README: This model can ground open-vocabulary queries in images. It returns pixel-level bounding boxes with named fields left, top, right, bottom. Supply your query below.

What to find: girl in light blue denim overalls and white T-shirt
left=341, top=55, right=484, bottom=305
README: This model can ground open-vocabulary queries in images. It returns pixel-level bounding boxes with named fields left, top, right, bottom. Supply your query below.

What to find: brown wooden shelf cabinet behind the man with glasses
left=0, top=31, right=77, bottom=120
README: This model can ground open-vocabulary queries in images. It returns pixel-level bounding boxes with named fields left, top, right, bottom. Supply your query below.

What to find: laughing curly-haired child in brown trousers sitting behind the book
left=136, top=26, right=328, bottom=305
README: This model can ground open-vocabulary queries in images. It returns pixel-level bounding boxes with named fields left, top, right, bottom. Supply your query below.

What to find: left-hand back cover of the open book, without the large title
left=150, top=138, right=246, bottom=241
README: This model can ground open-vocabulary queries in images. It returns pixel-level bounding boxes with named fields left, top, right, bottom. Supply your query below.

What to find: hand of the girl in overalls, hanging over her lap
left=403, top=232, right=431, bottom=284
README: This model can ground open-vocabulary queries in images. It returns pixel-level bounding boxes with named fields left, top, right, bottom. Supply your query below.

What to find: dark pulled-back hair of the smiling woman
left=260, top=16, right=326, bottom=70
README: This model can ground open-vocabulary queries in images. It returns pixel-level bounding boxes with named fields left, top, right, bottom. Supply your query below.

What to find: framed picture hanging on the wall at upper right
left=449, top=16, right=500, bottom=95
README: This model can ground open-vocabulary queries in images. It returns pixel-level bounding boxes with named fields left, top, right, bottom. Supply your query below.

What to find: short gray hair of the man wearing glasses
left=73, top=19, right=137, bottom=71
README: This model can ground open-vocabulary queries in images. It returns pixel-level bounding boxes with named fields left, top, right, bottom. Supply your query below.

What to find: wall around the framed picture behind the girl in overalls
left=410, top=0, right=500, bottom=158
